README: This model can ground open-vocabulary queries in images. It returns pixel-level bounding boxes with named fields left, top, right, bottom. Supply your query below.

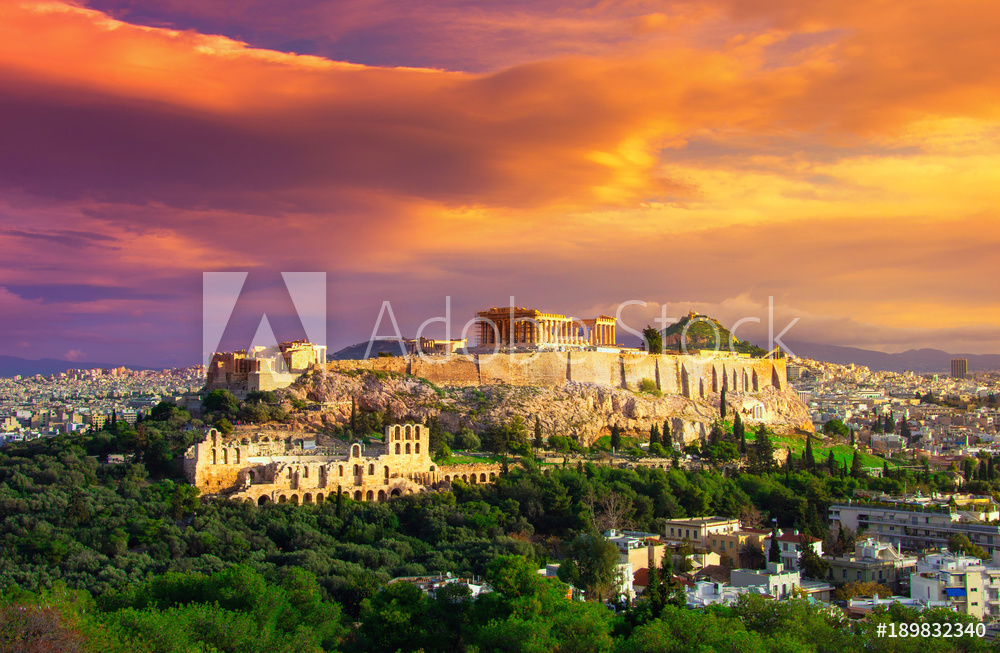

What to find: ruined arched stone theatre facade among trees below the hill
left=184, top=424, right=499, bottom=505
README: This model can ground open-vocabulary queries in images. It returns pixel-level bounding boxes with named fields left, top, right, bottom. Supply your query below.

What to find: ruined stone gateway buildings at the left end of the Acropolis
left=207, top=340, right=326, bottom=398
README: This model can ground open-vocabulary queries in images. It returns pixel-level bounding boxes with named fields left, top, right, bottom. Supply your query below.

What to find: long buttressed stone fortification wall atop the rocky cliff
left=328, top=351, right=788, bottom=392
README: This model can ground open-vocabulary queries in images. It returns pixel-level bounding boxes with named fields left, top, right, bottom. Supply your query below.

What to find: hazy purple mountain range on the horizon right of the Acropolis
left=785, top=341, right=1000, bottom=374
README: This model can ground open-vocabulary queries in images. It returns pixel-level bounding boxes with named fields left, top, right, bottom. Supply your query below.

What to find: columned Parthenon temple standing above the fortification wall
left=476, top=306, right=617, bottom=348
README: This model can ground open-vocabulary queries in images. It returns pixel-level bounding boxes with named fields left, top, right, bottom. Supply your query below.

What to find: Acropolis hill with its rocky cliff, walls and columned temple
left=219, top=308, right=812, bottom=444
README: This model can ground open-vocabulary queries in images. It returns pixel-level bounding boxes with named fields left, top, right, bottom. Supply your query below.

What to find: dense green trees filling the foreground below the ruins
left=0, top=428, right=996, bottom=652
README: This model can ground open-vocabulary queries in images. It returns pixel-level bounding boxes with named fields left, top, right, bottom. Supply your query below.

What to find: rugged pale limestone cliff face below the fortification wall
left=281, top=371, right=813, bottom=445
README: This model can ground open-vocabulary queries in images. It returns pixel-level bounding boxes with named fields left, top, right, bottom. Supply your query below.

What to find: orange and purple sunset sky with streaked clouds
left=0, top=0, right=1000, bottom=366
